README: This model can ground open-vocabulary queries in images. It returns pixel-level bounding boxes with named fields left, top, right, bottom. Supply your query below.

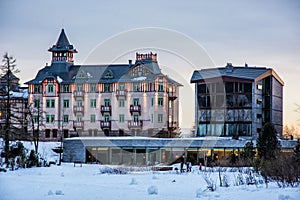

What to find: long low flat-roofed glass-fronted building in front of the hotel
left=63, top=137, right=297, bottom=166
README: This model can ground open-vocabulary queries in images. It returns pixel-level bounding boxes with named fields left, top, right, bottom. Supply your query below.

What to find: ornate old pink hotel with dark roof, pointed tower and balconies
left=27, top=30, right=181, bottom=140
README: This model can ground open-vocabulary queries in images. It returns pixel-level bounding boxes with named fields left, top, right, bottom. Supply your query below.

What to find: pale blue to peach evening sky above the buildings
left=0, top=0, right=300, bottom=130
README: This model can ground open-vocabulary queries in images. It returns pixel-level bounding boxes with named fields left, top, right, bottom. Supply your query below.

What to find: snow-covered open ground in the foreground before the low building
left=0, top=163, right=300, bottom=200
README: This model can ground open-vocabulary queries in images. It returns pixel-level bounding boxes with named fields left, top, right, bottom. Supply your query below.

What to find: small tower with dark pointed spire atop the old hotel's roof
left=48, top=29, right=77, bottom=63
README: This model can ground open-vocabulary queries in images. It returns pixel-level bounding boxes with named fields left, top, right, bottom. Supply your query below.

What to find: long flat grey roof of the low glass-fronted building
left=64, top=137, right=296, bottom=149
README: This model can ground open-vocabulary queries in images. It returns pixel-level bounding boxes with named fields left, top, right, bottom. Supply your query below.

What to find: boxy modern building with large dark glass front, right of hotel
left=191, top=63, right=284, bottom=138
